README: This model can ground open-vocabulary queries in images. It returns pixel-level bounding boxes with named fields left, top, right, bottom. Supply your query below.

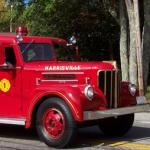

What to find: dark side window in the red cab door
left=5, top=47, right=16, bottom=65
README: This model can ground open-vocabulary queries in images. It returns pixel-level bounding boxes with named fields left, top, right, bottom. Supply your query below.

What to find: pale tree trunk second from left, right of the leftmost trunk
left=125, top=0, right=137, bottom=85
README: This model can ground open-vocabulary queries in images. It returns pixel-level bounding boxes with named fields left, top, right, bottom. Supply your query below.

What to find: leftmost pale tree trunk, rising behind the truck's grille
left=120, top=0, right=129, bottom=81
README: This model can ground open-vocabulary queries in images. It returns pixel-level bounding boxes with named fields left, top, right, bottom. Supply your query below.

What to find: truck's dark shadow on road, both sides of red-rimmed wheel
left=0, top=125, right=150, bottom=149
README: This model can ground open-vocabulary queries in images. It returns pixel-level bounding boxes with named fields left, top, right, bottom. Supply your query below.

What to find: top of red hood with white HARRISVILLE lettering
left=25, top=61, right=115, bottom=71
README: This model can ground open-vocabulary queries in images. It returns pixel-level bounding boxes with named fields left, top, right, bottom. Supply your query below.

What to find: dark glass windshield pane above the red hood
left=19, top=43, right=54, bottom=62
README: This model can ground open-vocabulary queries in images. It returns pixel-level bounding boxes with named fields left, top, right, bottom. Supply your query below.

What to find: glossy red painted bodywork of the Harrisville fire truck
left=0, top=34, right=135, bottom=127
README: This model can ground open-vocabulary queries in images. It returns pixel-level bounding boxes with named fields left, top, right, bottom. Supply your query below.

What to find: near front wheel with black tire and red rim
left=36, top=98, right=76, bottom=148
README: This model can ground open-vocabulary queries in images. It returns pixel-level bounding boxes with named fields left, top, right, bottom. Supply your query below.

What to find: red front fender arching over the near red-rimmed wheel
left=26, top=87, right=83, bottom=128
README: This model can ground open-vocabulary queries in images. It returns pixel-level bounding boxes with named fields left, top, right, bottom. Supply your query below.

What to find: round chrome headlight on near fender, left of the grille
left=84, top=85, right=94, bottom=100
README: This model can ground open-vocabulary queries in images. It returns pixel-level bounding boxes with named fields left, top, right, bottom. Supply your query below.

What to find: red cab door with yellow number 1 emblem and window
left=0, top=46, right=22, bottom=118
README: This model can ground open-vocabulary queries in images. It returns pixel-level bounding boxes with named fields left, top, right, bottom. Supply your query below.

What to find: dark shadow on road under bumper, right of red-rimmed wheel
left=75, top=126, right=150, bottom=148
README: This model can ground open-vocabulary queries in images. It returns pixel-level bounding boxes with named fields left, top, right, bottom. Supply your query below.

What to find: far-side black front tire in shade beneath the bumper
left=99, top=114, right=134, bottom=136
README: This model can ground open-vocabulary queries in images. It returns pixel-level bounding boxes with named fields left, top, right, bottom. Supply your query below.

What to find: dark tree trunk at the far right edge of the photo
left=143, top=0, right=150, bottom=89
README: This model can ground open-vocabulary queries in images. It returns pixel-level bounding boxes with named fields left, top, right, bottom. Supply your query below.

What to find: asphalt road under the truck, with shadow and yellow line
left=0, top=113, right=150, bottom=150
